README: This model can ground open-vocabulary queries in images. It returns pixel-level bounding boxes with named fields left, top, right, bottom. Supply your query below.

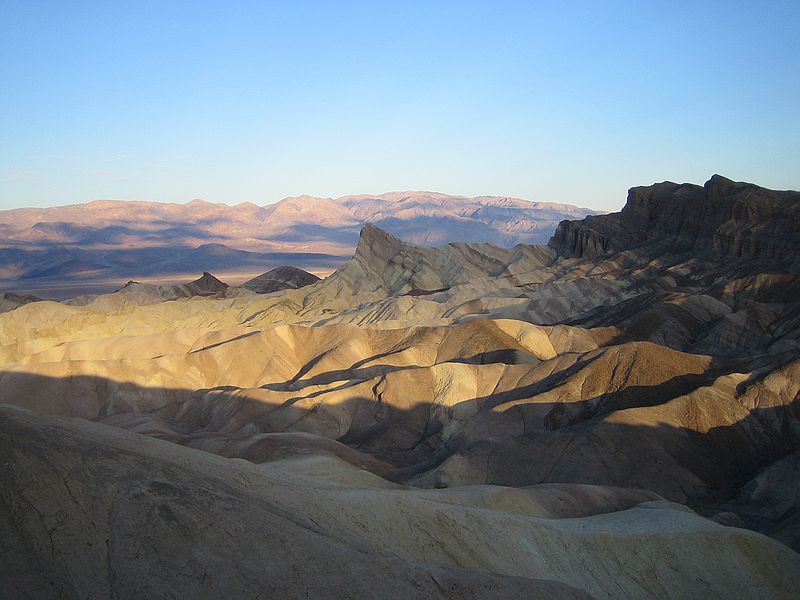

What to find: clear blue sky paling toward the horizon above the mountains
left=0, top=0, right=800, bottom=210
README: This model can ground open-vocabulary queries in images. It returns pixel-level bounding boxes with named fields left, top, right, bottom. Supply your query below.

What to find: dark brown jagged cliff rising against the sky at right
left=549, top=175, right=800, bottom=260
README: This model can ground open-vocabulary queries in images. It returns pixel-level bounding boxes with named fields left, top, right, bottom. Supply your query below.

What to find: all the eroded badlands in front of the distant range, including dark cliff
left=0, top=176, right=800, bottom=599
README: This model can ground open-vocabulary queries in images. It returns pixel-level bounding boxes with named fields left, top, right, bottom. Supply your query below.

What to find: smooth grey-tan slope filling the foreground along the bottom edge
left=0, top=408, right=800, bottom=600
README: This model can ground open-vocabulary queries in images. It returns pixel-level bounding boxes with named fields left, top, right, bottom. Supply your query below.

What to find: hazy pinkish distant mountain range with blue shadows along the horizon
left=0, top=192, right=596, bottom=298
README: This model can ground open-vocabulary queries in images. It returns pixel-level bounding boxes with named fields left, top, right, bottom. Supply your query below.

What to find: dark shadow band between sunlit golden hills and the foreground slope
left=0, top=372, right=800, bottom=552
